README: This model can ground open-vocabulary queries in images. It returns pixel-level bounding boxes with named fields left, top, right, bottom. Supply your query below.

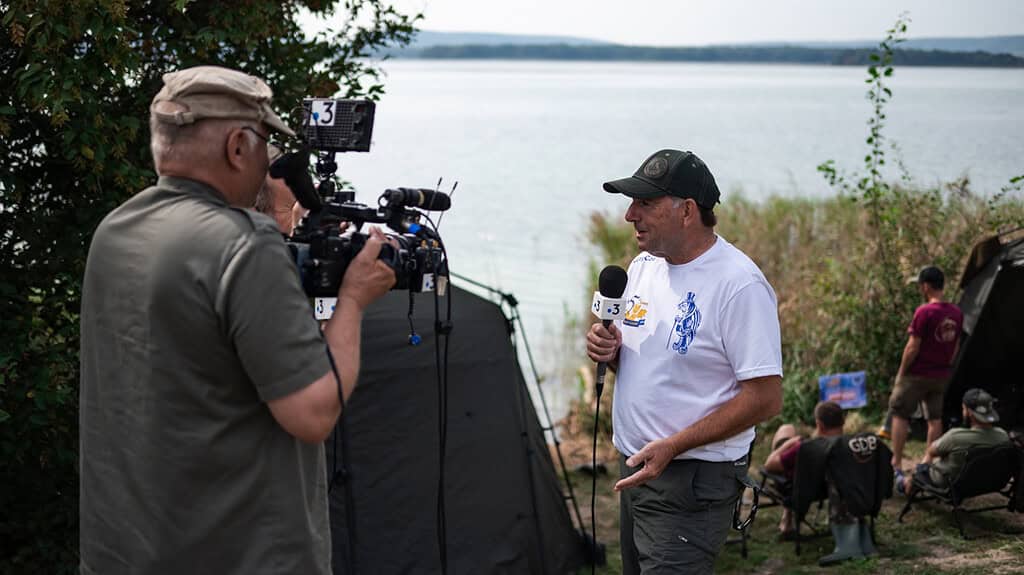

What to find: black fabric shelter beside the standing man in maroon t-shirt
left=943, top=234, right=1024, bottom=430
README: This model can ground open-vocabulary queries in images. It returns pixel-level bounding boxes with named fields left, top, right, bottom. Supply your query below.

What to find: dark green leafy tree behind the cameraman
left=0, top=0, right=419, bottom=573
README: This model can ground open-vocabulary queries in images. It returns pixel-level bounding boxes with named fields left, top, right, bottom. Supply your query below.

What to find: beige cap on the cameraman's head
left=150, top=65, right=295, bottom=136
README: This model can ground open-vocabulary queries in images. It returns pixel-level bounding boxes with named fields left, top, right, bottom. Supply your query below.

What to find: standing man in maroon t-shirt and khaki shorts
left=889, top=266, right=964, bottom=471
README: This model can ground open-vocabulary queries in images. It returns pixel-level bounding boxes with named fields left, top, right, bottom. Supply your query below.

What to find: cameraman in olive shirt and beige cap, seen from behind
left=80, top=67, right=395, bottom=574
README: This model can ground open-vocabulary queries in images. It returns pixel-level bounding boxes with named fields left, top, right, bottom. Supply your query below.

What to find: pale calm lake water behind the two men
left=339, top=60, right=1024, bottom=417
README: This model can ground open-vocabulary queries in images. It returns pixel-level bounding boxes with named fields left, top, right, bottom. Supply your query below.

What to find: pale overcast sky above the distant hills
left=364, top=0, right=1024, bottom=46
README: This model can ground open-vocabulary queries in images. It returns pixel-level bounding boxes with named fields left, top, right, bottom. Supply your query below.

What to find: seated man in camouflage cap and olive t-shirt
left=896, top=388, right=1010, bottom=493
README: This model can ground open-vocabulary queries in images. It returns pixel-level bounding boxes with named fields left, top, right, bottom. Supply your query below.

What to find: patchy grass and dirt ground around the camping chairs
left=563, top=423, right=1024, bottom=575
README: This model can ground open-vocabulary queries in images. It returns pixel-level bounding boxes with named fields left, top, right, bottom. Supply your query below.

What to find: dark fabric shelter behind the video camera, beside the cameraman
left=327, top=289, right=583, bottom=575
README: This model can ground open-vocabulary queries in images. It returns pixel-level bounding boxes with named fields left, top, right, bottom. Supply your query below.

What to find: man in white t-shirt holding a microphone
left=587, top=149, right=782, bottom=575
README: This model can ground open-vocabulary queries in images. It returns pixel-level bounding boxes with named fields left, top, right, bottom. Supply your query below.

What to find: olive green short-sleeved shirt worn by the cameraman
left=80, top=177, right=331, bottom=575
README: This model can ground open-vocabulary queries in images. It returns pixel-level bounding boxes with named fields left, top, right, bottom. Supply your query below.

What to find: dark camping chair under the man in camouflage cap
left=897, top=444, right=1022, bottom=539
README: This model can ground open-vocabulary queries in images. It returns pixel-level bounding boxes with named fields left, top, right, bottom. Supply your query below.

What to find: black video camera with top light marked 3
left=270, top=99, right=452, bottom=304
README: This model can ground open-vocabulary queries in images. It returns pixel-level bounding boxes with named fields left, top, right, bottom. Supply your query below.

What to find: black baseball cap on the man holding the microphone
left=604, top=149, right=721, bottom=210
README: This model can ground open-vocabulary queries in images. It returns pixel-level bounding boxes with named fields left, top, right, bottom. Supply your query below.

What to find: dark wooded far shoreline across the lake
left=407, top=44, right=1024, bottom=68
